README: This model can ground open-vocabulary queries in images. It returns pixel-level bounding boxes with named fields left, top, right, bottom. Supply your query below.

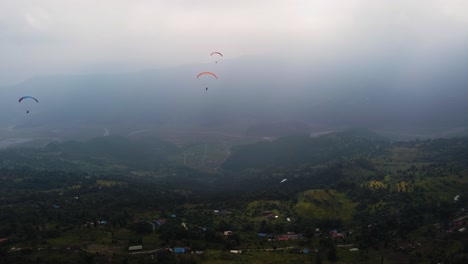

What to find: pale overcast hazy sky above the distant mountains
left=0, top=0, right=468, bottom=85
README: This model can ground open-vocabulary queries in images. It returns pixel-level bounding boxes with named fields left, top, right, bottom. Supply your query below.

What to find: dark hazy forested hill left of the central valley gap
left=0, top=136, right=180, bottom=172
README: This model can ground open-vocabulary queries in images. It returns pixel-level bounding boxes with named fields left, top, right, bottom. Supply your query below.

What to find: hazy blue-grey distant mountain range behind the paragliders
left=0, top=54, right=468, bottom=138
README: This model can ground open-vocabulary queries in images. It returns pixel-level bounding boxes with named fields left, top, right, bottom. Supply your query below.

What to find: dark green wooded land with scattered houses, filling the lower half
left=0, top=130, right=468, bottom=263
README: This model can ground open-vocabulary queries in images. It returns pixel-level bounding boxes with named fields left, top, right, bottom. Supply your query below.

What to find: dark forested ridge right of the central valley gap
left=223, top=129, right=390, bottom=171
